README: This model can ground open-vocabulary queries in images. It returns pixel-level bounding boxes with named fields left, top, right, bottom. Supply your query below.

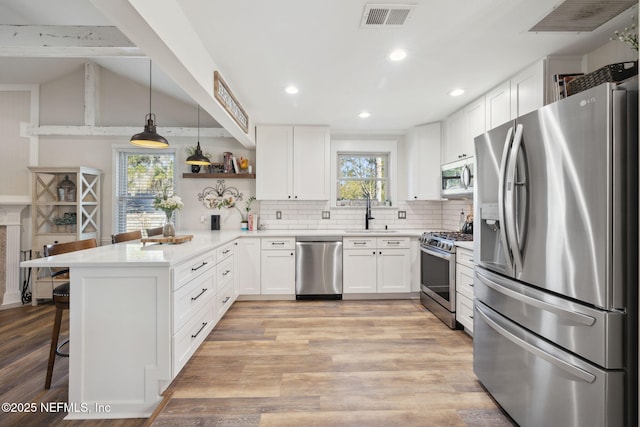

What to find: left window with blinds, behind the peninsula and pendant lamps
left=114, top=149, right=175, bottom=233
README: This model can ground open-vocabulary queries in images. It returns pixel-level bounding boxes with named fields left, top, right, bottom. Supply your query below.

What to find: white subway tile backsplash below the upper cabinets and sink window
left=260, top=200, right=473, bottom=230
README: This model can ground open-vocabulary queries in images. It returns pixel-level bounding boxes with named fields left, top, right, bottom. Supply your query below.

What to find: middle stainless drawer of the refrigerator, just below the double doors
left=474, top=268, right=625, bottom=369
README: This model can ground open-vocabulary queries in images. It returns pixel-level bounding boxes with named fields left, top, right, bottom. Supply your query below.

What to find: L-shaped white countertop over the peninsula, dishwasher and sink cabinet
left=20, top=230, right=430, bottom=267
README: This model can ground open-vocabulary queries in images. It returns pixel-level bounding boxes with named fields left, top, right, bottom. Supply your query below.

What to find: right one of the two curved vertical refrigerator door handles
left=504, top=124, right=523, bottom=275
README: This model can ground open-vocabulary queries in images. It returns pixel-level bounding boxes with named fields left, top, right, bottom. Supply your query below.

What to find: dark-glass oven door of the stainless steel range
left=420, top=247, right=456, bottom=313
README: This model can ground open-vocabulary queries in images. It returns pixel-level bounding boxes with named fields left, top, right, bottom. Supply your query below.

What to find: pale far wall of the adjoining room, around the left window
left=0, top=61, right=258, bottom=249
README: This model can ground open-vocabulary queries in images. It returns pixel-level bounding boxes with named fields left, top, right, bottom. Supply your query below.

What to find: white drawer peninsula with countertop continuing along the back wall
left=21, top=230, right=419, bottom=419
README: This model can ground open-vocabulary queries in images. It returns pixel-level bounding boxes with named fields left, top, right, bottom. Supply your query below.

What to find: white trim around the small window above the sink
left=331, top=139, right=398, bottom=209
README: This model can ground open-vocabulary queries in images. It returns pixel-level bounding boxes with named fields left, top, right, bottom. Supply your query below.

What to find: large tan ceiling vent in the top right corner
left=529, top=0, right=638, bottom=32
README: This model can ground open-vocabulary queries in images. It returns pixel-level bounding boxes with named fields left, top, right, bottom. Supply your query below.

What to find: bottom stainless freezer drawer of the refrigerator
left=473, top=301, right=625, bottom=427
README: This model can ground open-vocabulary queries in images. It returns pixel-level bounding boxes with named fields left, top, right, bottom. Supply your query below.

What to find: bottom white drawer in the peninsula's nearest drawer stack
left=173, top=304, right=215, bottom=377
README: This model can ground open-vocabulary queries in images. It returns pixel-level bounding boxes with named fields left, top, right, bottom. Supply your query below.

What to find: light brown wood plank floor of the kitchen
left=0, top=300, right=512, bottom=427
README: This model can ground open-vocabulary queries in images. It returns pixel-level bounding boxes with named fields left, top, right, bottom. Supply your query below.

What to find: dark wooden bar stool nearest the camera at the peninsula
left=44, top=239, right=98, bottom=389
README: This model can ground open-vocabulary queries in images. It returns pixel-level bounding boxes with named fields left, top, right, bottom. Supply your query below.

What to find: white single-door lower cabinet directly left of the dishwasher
left=260, top=237, right=296, bottom=295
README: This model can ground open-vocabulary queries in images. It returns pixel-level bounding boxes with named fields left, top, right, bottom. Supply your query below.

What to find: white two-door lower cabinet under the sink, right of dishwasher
left=342, top=237, right=411, bottom=294
